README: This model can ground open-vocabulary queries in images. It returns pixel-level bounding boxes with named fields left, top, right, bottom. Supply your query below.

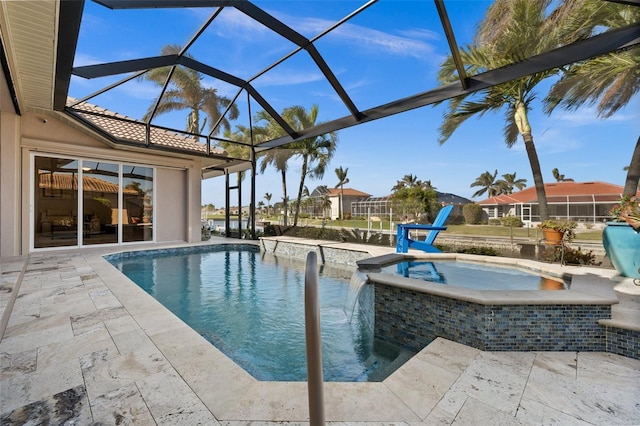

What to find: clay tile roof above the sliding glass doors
left=67, top=98, right=225, bottom=155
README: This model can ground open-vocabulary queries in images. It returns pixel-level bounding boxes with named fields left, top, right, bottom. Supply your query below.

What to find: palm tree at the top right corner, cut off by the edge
left=545, top=0, right=640, bottom=195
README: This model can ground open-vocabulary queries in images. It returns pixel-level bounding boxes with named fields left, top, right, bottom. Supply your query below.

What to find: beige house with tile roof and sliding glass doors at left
left=0, top=89, right=245, bottom=255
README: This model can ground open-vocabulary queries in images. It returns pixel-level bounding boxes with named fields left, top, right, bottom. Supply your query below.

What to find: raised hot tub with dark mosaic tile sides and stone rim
left=357, top=253, right=618, bottom=351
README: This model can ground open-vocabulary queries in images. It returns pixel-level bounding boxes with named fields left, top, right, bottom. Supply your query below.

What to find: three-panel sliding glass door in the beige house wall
left=32, top=156, right=154, bottom=248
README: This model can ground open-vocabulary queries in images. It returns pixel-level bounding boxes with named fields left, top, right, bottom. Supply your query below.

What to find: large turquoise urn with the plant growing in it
left=602, top=195, right=640, bottom=284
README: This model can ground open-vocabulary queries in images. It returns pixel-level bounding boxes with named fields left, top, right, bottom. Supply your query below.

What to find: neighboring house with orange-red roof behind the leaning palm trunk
left=478, top=182, right=640, bottom=225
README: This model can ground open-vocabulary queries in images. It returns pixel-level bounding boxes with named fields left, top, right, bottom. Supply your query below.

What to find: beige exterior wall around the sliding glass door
left=0, top=110, right=201, bottom=256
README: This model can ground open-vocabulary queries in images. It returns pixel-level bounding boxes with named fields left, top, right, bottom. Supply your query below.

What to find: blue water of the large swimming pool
left=110, top=247, right=413, bottom=382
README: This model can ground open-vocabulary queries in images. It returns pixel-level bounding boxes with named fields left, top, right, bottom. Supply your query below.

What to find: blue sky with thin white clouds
left=70, top=0, right=640, bottom=206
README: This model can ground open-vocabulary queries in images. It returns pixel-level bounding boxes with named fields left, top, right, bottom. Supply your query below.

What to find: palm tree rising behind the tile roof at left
left=143, top=45, right=239, bottom=134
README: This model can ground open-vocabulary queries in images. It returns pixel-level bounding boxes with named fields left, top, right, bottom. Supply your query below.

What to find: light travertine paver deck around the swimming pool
left=0, top=243, right=640, bottom=426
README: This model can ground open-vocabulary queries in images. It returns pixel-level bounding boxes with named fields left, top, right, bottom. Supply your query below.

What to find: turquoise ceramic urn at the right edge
left=602, top=222, right=640, bottom=278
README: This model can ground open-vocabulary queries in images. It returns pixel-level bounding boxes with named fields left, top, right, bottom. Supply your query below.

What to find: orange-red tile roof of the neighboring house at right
left=478, top=182, right=640, bottom=205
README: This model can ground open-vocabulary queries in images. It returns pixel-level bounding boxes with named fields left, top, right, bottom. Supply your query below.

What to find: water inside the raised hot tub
left=381, top=261, right=570, bottom=290
